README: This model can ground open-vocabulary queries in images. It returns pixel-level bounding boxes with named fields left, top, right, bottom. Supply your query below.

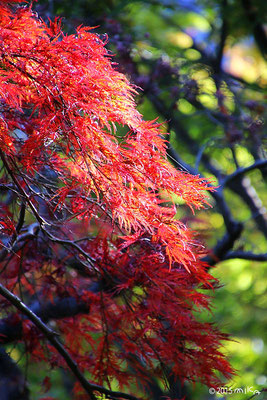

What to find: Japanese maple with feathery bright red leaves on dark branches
left=0, top=1, right=232, bottom=399
